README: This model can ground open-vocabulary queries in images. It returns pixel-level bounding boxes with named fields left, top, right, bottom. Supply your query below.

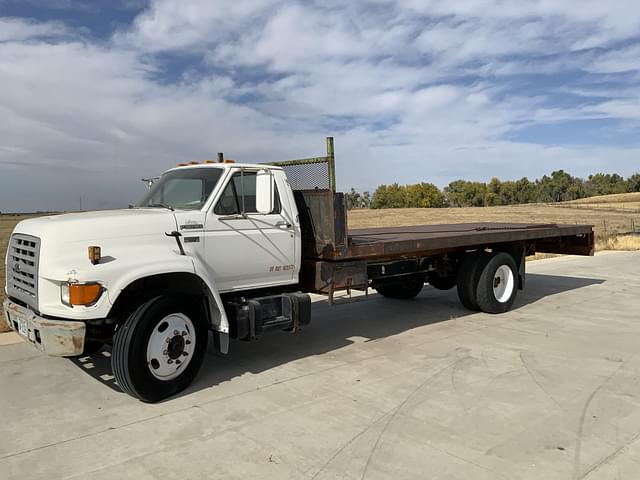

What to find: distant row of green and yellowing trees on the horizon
left=347, top=170, right=640, bottom=209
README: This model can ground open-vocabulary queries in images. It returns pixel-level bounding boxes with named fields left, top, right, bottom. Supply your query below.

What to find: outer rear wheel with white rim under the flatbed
left=476, top=252, right=518, bottom=313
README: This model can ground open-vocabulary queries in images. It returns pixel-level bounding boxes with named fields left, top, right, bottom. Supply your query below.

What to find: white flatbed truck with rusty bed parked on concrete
left=3, top=137, right=594, bottom=402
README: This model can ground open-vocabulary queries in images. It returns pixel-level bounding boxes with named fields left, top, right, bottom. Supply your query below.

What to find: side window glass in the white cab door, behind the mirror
left=213, top=172, right=282, bottom=215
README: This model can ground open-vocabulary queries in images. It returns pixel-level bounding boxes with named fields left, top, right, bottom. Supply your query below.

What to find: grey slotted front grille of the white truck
left=7, top=233, right=40, bottom=309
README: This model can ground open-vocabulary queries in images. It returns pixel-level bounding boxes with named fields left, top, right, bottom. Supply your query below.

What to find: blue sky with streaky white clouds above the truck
left=0, top=0, right=640, bottom=211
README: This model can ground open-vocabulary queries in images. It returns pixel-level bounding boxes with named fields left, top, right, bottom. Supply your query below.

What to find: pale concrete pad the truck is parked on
left=0, top=252, right=640, bottom=480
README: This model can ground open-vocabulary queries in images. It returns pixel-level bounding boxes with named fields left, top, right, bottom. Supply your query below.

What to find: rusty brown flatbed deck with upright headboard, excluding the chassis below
left=270, top=137, right=594, bottom=303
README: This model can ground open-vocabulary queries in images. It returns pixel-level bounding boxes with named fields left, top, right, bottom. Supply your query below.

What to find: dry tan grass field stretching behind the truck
left=0, top=193, right=640, bottom=312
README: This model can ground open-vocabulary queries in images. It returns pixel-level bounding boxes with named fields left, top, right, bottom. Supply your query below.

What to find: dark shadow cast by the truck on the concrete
left=72, top=274, right=605, bottom=401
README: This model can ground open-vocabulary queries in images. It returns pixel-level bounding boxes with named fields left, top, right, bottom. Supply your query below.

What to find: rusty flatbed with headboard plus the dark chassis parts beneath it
left=277, top=138, right=594, bottom=307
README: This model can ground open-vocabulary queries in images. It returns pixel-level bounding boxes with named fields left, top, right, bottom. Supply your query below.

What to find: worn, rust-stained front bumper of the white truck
left=2, top=298, right=87, bottom=357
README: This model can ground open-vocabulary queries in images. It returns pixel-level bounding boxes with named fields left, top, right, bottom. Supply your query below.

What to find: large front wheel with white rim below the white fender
left=111, top=297, right=208, bottom=402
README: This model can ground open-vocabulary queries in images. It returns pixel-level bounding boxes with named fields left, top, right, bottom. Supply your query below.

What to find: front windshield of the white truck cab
left=136, top=168, right=222, bottom=210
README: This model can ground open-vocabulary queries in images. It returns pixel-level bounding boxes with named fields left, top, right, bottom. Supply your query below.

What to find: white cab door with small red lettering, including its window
left=204, top=168, right=297, bottom=291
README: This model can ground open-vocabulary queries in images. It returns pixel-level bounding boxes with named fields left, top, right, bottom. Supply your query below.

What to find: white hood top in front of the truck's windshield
left=14, top=208, right=176, bottom=243
